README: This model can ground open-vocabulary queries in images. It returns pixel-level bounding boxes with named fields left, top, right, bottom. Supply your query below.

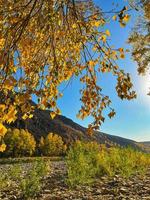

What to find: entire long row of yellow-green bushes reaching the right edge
left=66, top=141, right=150, bottom=187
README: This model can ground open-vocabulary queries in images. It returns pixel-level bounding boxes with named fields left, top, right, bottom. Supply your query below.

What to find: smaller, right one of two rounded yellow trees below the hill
left=39, top=133, right=66, bottom=156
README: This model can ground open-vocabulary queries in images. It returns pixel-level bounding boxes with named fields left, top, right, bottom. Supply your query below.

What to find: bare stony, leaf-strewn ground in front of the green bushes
left=0, top=161, right=150, bottom=200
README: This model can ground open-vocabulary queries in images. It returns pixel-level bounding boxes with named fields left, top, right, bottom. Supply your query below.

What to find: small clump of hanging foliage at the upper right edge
left=128, top=0, right=150, bottom=75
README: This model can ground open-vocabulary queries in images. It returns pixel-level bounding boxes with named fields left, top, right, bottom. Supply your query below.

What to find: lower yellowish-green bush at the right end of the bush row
left=98, top=147, right=150, bottom=177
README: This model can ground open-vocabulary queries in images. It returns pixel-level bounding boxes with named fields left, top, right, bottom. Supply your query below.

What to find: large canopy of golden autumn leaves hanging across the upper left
left=0, top=0, right=136, bottom=151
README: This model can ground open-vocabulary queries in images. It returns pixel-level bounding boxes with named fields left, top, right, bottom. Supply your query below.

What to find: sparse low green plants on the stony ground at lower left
left=0, top=158, right=50, bottom=199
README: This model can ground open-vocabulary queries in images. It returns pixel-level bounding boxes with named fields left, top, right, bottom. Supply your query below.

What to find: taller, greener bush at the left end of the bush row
left=66, top=141, right=99, bottom=187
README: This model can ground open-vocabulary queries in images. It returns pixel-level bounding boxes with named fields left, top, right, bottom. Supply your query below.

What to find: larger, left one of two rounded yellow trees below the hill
left=4, top=129, right=36, bottom=157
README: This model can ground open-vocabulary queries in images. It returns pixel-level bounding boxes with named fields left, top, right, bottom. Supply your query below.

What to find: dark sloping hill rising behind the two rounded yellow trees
left=9, top=101, right=146, bottom=151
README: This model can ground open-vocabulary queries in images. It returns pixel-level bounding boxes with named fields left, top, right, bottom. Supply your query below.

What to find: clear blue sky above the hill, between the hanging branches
left=41, top=0, right=150, bottom=141
